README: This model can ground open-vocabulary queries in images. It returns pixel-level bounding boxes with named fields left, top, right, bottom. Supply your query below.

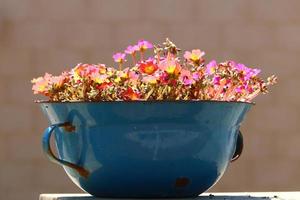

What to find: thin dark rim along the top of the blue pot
left=34, top=100, right=256, bottom=106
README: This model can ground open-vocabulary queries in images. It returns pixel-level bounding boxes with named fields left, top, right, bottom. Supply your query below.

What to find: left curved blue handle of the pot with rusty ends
left=42, top=122, right=89, bottom=178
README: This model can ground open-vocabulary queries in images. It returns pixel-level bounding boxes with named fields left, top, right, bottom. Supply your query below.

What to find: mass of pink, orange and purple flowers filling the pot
left=32, top=39, right=277, bottom=102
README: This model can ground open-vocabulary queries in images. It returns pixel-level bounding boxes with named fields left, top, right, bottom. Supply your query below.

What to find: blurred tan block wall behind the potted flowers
left=0, top=0, right=300, bottom=200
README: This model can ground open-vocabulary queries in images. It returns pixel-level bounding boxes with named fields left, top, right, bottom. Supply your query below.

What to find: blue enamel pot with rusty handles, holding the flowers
left=40, top=101, right=252, bottom=198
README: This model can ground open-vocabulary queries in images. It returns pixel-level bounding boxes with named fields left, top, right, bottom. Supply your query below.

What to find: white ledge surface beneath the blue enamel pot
left=40, top=192, right=300, bottom=200
